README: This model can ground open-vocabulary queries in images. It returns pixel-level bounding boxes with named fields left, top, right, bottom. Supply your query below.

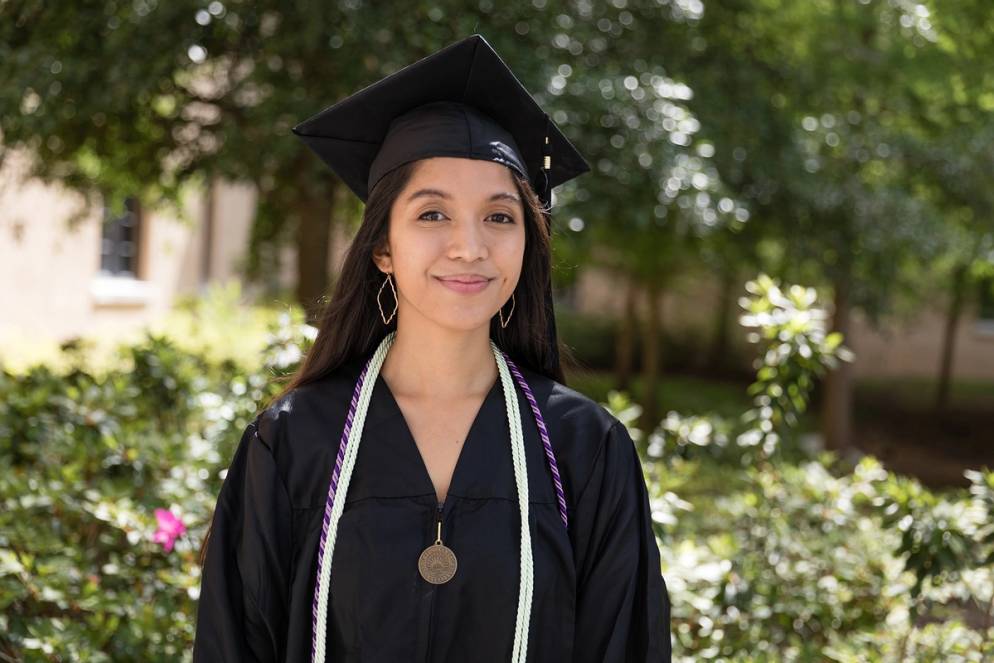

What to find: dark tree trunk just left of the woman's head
left=295, top=180, right=338, bottom=324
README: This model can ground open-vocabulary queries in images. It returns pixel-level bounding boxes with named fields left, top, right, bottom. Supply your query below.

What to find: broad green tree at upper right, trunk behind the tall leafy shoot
left=648, top=0, right=979, bottom=448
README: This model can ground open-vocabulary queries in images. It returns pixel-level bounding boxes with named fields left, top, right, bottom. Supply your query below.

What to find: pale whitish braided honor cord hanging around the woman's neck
left=312, top=331, right=534, bottom=663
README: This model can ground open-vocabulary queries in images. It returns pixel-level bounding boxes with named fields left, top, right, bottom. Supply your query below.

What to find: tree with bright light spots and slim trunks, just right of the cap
left=548, top=2, right=748, bottom=422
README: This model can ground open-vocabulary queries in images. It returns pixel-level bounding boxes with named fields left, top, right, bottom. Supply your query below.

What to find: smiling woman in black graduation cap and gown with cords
left=193, top=35, right=671, bottom=663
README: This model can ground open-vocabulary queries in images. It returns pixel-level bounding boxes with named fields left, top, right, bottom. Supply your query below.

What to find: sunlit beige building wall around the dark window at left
left=0, top=153, right=254, bottom=357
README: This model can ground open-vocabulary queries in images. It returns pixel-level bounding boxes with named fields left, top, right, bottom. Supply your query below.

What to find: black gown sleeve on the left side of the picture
left=193, top=419, right=293, bottom=663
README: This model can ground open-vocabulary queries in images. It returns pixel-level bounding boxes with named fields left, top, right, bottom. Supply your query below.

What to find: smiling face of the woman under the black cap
left=374, top=157, right=525, bottom=330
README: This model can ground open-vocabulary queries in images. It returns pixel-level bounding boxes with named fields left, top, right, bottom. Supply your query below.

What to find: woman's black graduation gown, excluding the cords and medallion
left=193, top=361, right=671, bottom=663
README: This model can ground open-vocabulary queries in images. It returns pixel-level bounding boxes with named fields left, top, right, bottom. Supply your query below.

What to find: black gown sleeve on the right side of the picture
left=571, top=421, right=672, bottom=663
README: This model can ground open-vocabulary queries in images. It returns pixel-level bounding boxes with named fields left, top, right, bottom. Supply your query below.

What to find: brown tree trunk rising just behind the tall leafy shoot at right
left=822, top=272, right=853, bottom=451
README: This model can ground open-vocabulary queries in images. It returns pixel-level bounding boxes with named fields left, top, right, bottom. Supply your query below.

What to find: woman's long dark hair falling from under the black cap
left=200, top=161, right=575, bottom=566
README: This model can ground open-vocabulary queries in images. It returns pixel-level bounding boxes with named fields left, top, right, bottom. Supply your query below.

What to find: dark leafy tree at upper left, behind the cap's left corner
left=0, top=0, right=560, bottom=315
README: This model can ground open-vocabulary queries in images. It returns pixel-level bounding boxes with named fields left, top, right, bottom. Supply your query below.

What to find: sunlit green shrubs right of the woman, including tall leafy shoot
left=607, top=276, right=994, bottom=662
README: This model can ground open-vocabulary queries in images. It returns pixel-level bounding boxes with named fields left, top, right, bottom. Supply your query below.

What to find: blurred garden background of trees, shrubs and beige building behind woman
left=0, top=0, right=994, bottom=662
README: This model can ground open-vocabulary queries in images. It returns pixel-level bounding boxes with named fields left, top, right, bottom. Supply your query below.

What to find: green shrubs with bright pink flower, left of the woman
left=0, top=313, right=314, bottom=661
